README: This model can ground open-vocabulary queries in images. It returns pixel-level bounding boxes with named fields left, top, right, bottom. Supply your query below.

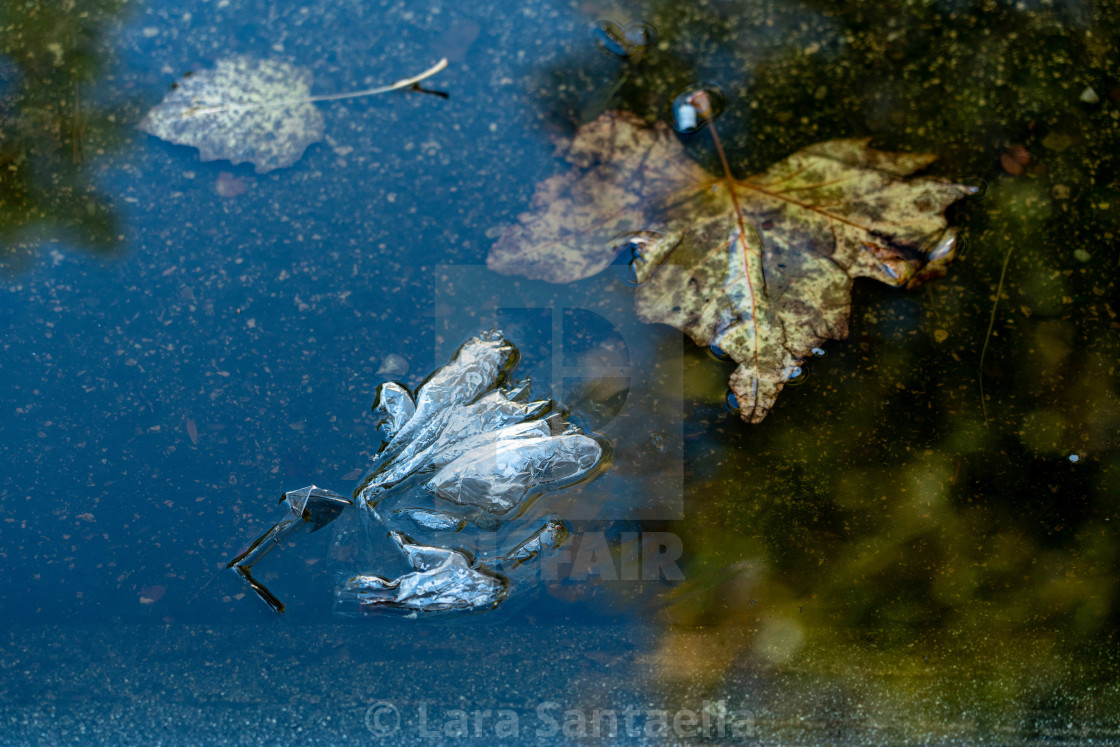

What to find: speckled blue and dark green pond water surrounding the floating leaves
left=0, top=0, right=1120, bottom=745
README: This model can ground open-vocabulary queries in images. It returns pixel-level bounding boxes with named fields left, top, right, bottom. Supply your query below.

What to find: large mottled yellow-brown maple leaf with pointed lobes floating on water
left=487, top=112, right=971, bottom=422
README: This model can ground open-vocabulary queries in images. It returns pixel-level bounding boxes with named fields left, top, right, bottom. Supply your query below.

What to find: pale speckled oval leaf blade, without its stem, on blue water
left=138, top=56, right=323, bottom=174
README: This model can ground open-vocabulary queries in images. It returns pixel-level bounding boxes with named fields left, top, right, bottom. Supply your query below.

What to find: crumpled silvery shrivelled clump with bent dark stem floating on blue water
left=228, top=332, right=609, bottom=615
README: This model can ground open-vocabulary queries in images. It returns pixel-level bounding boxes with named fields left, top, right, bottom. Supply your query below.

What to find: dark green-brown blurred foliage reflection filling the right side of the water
left=538, top=0, right=1120, bottom=736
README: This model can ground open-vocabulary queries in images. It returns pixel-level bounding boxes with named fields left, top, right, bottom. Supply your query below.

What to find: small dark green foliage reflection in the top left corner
left=0, top=0, right=127, bottom=272
